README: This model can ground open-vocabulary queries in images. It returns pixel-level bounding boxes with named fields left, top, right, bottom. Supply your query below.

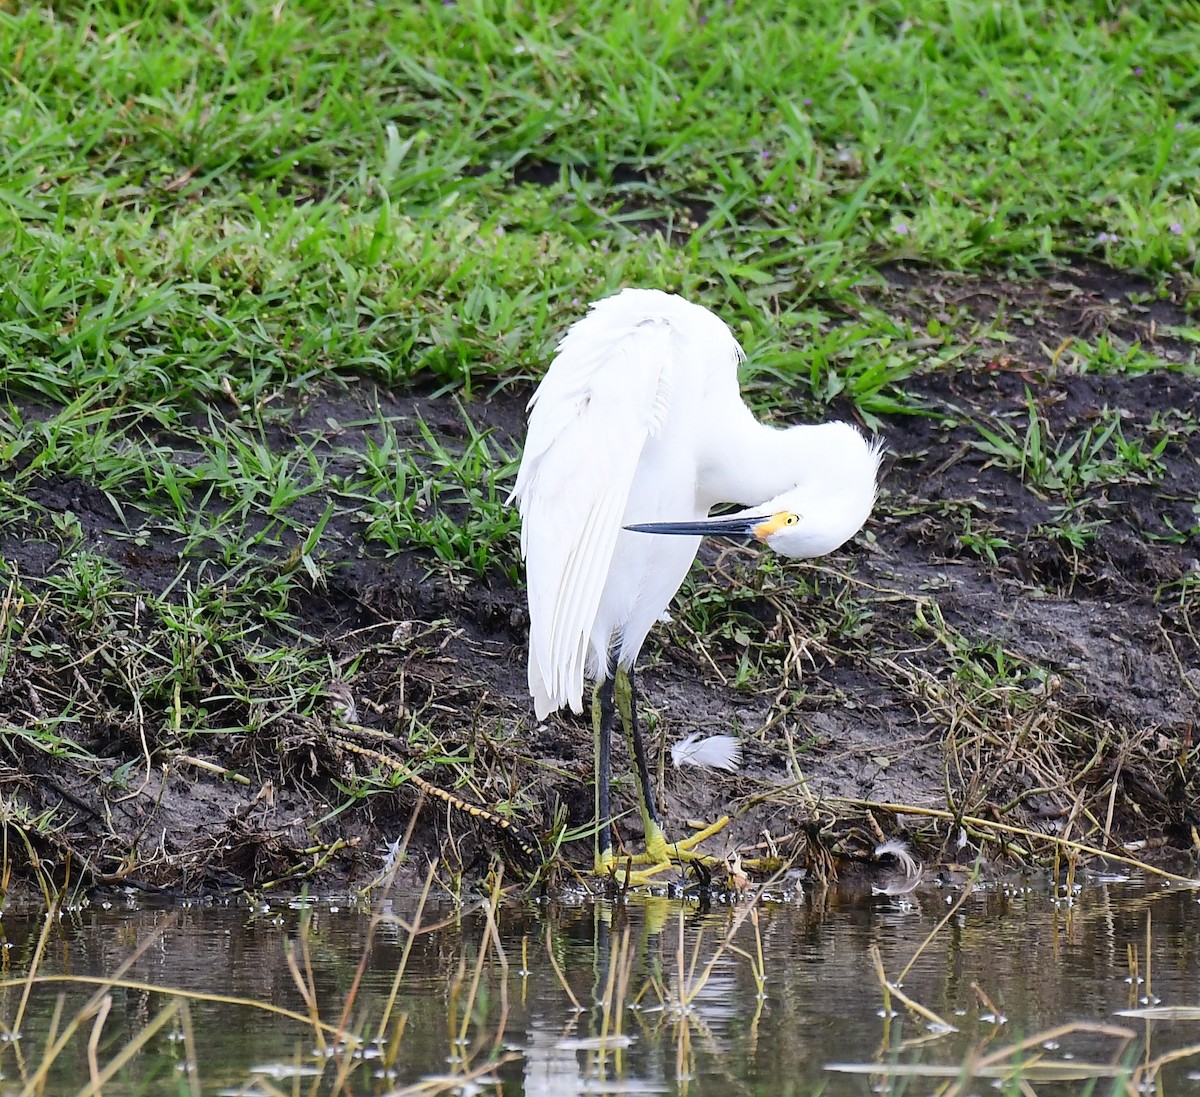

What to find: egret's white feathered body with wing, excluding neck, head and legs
left=512, top=289, right=740, bottom=719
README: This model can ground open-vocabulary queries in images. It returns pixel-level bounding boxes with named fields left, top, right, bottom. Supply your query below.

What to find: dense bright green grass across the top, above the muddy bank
left=0, top=2, right=1200, bottom=404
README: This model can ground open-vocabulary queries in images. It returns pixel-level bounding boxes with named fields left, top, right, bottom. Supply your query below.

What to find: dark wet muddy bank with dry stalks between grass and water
left=0, top=268, right=1200, bottom=892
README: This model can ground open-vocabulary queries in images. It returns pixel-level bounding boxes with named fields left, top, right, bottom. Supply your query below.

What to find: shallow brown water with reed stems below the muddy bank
left=0, top=880, right=1200, bottom=1095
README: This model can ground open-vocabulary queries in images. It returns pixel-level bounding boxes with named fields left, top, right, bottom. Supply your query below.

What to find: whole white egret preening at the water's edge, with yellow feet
left=512, top=289, right=881, bottom=886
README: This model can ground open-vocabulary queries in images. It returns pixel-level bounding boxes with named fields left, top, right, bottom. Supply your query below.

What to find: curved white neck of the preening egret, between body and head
left=696, top=406, right=844, bottom=514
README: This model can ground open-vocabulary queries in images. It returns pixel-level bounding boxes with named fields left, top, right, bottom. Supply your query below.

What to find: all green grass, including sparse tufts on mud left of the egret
left=0, top=0, right=1200, bottom=878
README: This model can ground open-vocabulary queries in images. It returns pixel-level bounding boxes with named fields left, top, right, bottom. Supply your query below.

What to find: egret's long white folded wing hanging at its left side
left=512, top=306, right=673, bottom=719
